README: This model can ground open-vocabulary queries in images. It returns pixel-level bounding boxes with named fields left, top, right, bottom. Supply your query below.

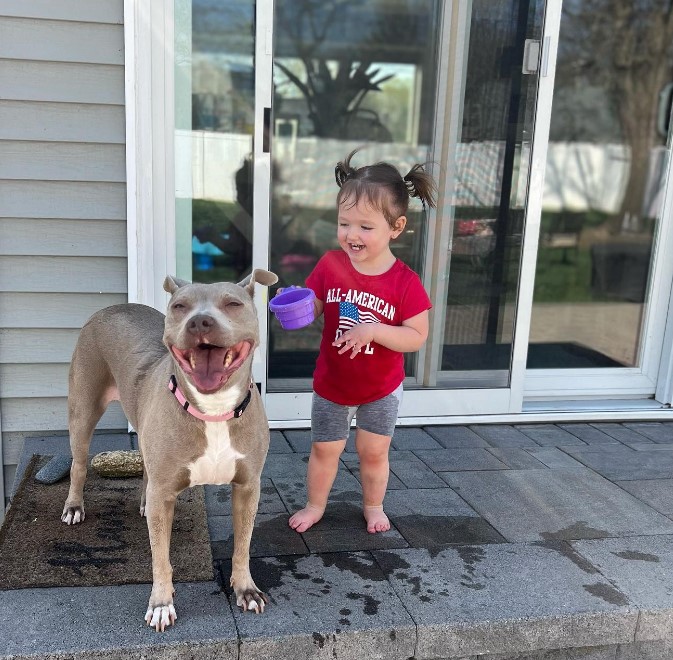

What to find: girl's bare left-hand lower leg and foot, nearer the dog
left=289, top=440, right=346, bottom=532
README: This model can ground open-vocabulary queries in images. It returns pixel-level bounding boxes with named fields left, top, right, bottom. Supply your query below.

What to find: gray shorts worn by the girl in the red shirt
left=311, top=384, right=402, bottom=442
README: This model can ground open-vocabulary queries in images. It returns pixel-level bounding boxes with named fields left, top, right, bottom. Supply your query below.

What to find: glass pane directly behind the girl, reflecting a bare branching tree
left=268, top=0, right=442, bottom=391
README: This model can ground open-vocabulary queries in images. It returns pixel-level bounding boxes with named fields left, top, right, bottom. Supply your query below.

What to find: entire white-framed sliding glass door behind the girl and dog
left=164, top=0, right=673, bottom=423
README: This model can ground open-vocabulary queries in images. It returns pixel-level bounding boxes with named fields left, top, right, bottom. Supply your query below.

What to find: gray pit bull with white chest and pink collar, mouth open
left=61, top=269, right=278, bottom=631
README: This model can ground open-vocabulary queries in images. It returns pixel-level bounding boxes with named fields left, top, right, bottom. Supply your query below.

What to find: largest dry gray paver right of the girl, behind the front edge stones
left=443, top=469, right=673, bottom=541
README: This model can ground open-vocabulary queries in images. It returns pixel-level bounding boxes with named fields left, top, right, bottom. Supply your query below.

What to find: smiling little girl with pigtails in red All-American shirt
left=289, top=151, right=436, bottom=533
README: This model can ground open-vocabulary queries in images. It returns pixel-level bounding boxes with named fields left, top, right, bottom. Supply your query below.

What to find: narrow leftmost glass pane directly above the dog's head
left=175, top=0, right=255, bottom=282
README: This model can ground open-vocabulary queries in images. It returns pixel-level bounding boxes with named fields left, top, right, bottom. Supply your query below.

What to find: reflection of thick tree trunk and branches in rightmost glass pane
left=556, top=0, right=673, bottom=233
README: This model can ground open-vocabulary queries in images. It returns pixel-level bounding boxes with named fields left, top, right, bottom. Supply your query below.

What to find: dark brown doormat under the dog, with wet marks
left=0, top=456, right=213, bottom=589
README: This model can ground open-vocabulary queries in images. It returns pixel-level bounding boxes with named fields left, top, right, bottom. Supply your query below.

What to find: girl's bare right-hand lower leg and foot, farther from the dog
left=355, top=428, right=392, bottom=534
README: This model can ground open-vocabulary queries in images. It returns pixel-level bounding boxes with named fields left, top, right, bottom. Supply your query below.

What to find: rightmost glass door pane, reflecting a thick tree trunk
left=528, top=0, right=673, bottom=372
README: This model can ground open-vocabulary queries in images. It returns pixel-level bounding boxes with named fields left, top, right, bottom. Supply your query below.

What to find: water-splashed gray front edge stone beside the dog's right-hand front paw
left=227, top=553, right=416, bottom=660
